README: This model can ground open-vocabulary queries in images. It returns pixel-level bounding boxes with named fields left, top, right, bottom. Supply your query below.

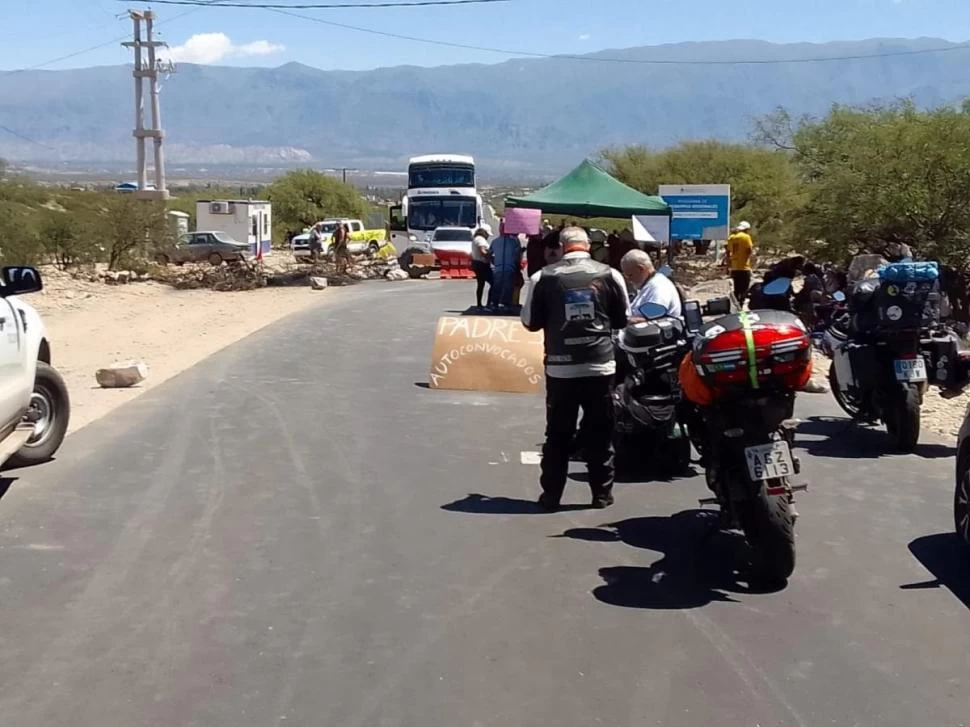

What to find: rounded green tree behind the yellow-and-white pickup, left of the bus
left=266, top=169, right=367, bottom=239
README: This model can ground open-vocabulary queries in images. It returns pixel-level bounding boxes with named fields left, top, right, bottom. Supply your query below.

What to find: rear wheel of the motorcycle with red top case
left=735, top=485, right=795, bottom=583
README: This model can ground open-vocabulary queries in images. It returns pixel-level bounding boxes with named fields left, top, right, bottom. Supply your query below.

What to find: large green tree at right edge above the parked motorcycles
left=758, top=102, right=970, bottom=272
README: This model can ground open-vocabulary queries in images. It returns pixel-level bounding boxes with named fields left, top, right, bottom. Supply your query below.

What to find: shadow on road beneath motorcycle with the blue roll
left=795, top=417, right=956, bottom=459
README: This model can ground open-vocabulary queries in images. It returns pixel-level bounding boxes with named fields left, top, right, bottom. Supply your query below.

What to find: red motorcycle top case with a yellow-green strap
left=693, top=310, right=812, bottom=393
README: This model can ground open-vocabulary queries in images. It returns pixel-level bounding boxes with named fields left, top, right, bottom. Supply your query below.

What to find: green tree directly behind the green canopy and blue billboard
left=603, top=141, right=798, bottom=247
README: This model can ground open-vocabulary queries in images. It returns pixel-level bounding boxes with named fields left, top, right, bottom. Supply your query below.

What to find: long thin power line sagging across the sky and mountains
left=264, top=5, right=970, bottom=66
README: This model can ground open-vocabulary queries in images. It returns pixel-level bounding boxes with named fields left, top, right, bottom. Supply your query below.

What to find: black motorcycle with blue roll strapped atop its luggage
left=824, top=263, right=966, bottom=453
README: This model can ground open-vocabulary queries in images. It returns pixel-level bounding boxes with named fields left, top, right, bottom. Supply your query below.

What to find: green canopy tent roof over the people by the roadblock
left=505, top=159, right=671, bottom=218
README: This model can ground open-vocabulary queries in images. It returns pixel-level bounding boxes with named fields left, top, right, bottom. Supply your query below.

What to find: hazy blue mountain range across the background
left=0, top=38, right=970, bottom=172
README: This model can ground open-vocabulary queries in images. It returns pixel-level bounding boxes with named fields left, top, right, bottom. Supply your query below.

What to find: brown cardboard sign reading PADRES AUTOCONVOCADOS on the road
left=428, top=316, right=544, bottom=394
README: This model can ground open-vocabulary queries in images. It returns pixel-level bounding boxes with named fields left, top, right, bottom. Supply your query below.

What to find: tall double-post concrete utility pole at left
left=122, top=10, right=172, bottom=199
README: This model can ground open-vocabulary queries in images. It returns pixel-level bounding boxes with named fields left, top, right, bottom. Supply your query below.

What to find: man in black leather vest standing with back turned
left=522, top=227, right=630, bottom=510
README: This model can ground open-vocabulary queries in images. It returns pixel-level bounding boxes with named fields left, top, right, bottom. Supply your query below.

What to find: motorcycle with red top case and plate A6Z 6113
left=680, top=310, right=812, bottom=582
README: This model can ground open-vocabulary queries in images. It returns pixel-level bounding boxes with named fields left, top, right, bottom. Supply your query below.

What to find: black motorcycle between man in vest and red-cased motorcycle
left=613, top=303, right=691, bottom=475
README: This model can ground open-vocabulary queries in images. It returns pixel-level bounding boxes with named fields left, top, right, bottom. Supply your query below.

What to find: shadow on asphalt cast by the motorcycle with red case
left=556, top=510, right=780, bottom=610
